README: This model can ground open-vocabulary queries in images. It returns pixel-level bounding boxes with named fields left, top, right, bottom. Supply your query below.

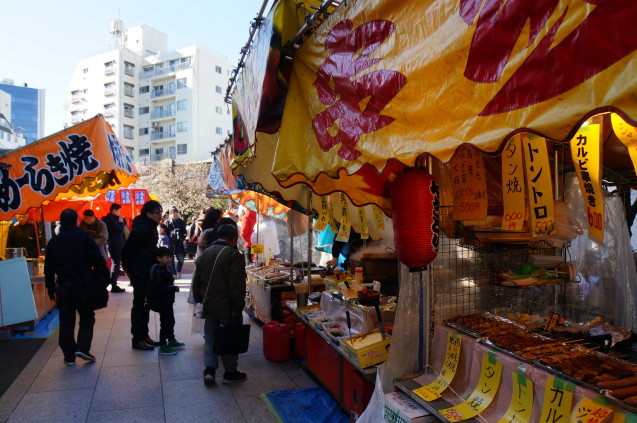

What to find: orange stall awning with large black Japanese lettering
left=0, top=115, right=139, bottom=220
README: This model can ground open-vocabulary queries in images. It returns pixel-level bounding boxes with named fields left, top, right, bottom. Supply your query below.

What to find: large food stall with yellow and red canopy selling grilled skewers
left=225, top=0, right=637, bottom=422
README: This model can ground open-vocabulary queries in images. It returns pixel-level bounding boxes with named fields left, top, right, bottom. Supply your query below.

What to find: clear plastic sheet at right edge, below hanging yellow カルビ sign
left=564, top=174, right=637, bottom=332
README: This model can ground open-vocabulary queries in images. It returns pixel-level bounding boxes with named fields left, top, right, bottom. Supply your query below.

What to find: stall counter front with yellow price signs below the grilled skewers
left=396, top=325, right=636, bottom=423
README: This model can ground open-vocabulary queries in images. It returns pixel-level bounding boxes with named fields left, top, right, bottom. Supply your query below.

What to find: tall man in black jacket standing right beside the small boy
left=122, top=200, right=163, bottom=350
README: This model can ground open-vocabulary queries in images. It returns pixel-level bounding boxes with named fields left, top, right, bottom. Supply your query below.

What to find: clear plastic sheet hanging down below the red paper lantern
left=357, top=265, right=428, bottom=423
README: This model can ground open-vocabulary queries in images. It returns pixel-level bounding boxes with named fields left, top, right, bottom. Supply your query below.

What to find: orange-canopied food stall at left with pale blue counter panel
left=0, top=115, right=138, bottom=330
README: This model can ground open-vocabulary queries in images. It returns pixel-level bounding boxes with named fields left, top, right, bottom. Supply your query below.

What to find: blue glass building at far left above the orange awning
left=0, top=79, right=45, bottom=144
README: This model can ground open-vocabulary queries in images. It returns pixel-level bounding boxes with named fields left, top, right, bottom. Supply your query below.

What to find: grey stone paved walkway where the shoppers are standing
left=0, top=263, right=316, bottom=423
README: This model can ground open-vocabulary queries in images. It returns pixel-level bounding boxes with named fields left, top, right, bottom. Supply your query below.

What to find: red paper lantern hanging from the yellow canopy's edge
left=391, top=168, right=440, bottom=272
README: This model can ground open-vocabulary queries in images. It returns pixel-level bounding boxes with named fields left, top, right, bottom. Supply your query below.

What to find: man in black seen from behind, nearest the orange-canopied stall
left=44, top=209, right=108, bottom=366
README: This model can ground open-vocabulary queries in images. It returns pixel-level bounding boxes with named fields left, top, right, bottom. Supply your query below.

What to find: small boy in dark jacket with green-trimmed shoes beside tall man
left=146, top=247, right=185, bottom=355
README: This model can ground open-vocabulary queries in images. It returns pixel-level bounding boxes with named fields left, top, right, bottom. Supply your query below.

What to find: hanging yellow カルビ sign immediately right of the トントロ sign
left=571, top=124, right=604, bottom=243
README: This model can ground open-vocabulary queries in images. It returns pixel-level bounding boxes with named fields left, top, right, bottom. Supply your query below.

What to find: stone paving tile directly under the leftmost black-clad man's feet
left=28, top=353, right=104, bottom=393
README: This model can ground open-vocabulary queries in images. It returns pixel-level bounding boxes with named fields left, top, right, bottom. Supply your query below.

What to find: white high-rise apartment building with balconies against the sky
left=66, top=20, right=232, bottom=163
